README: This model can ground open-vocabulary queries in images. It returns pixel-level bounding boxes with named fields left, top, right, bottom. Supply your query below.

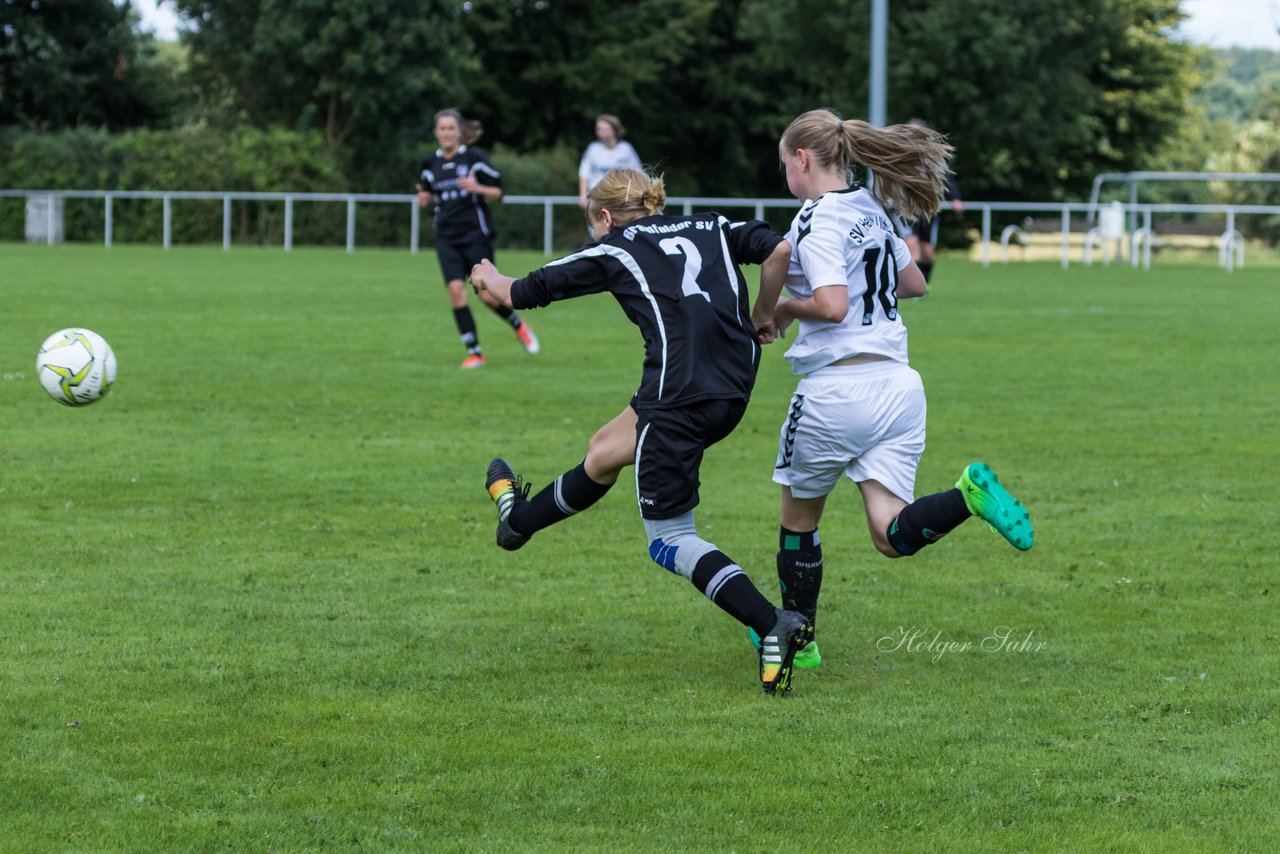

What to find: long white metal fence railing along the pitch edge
left=0, top=189, right=1280, bottom=270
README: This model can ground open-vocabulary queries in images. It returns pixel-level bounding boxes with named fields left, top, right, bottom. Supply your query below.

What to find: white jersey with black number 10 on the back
left=787, top=186, right=911, bottom=374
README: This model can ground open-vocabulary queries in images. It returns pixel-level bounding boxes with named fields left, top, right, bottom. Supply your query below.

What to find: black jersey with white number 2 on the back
left=511, top=214, right=782, bottom=408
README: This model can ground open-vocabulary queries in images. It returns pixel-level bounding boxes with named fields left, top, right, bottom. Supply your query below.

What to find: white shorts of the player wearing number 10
left=773, top=361, right=925, bottom=503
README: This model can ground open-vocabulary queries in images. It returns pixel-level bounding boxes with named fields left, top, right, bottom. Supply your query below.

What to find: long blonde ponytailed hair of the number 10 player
left=782, top=110, right=955, bottom=219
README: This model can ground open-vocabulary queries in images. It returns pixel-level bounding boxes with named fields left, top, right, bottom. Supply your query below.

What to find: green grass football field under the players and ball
left=0, top=245, right=1280, bottom=851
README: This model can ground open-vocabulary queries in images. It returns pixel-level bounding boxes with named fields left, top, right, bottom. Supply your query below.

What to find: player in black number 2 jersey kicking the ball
left=471, top=169, right=813, bottom=694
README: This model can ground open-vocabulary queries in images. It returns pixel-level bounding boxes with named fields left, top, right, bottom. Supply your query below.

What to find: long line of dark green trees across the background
left=0, top=0, right=1269, bottom=212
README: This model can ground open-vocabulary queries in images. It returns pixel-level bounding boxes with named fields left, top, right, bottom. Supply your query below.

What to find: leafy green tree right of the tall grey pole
left=890, top=0, right=1201, bottom=198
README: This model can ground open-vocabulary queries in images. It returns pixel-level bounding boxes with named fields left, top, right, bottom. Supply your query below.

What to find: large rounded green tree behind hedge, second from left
left=167, top=0, right=474, bottom=188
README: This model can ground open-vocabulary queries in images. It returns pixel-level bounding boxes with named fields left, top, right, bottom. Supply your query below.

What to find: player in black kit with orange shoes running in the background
left=417, top=109, right=538, bottom=367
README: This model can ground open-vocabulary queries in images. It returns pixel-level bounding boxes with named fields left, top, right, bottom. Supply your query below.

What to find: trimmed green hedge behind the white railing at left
left=0, top=127, right=586, bottom=248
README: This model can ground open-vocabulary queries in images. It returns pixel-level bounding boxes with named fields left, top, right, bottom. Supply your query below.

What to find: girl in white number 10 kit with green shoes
left=756, top=110, right=1034, bottom=667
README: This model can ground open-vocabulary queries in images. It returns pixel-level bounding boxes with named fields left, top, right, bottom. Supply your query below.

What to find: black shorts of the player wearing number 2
left=636, top=399, right=746, bottom=519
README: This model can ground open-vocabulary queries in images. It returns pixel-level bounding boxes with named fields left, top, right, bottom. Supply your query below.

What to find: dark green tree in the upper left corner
left=0, top=0, right=173, bottom=131
